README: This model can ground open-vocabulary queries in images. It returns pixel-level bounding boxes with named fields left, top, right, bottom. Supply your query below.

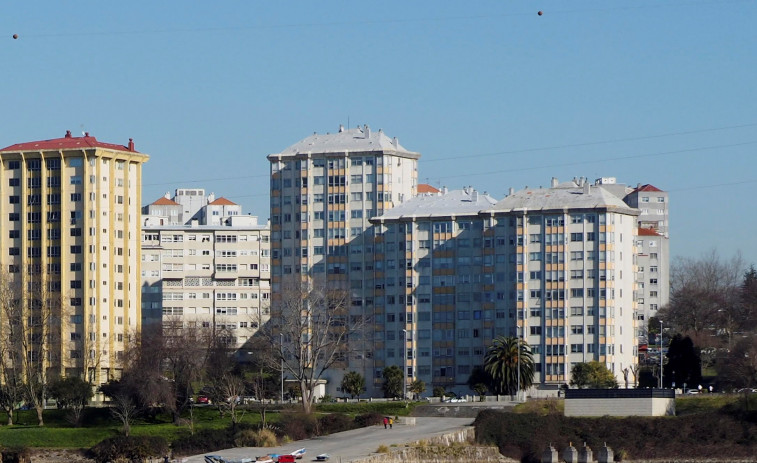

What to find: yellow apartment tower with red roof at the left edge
left=0, top=132, right=148, bottom=384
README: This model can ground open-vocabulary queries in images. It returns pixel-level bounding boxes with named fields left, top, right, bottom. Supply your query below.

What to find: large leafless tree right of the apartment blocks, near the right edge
left=659, top=250, right=746, bottom=347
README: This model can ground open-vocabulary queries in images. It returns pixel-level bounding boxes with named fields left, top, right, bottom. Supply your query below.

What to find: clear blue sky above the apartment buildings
left=0, top=0, right=757, bottom=263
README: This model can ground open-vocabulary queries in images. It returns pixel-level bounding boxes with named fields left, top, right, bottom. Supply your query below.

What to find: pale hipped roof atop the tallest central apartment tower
left=270, top=125, right=420, bottom=159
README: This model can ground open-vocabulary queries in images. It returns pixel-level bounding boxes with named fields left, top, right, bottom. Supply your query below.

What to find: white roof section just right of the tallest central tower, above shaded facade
left=372, top=188, right=497, bottom=221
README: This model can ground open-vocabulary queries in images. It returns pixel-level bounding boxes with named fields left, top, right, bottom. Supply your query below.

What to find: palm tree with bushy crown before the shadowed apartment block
left=484, top=336, right=534, bottom=396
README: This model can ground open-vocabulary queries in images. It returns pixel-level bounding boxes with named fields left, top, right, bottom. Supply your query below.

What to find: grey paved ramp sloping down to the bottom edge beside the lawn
left=187, top=418, right=473, bottom=463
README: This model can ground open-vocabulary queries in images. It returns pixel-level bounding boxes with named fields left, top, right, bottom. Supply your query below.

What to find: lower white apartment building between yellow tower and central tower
left=141, top=195, right=270, bottom=352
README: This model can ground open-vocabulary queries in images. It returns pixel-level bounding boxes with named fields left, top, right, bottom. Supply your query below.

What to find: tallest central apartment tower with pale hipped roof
left=268, top=126, right=420, bottom=394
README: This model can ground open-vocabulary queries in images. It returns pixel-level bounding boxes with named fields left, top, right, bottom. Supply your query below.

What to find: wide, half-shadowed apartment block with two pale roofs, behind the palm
left=373, top=180, right=638, bottom=393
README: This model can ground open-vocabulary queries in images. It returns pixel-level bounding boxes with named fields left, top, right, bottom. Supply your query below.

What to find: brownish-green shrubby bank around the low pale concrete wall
left=475, top=394, right=757, bottom=462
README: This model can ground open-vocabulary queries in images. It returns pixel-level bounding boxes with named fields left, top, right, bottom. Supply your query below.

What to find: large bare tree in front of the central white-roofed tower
left=258, top=282, right=362, bottom=413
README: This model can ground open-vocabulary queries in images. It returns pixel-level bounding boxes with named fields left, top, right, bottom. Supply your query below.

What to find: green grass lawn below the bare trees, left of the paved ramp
left=0, top=402, right=415, bottom=448
